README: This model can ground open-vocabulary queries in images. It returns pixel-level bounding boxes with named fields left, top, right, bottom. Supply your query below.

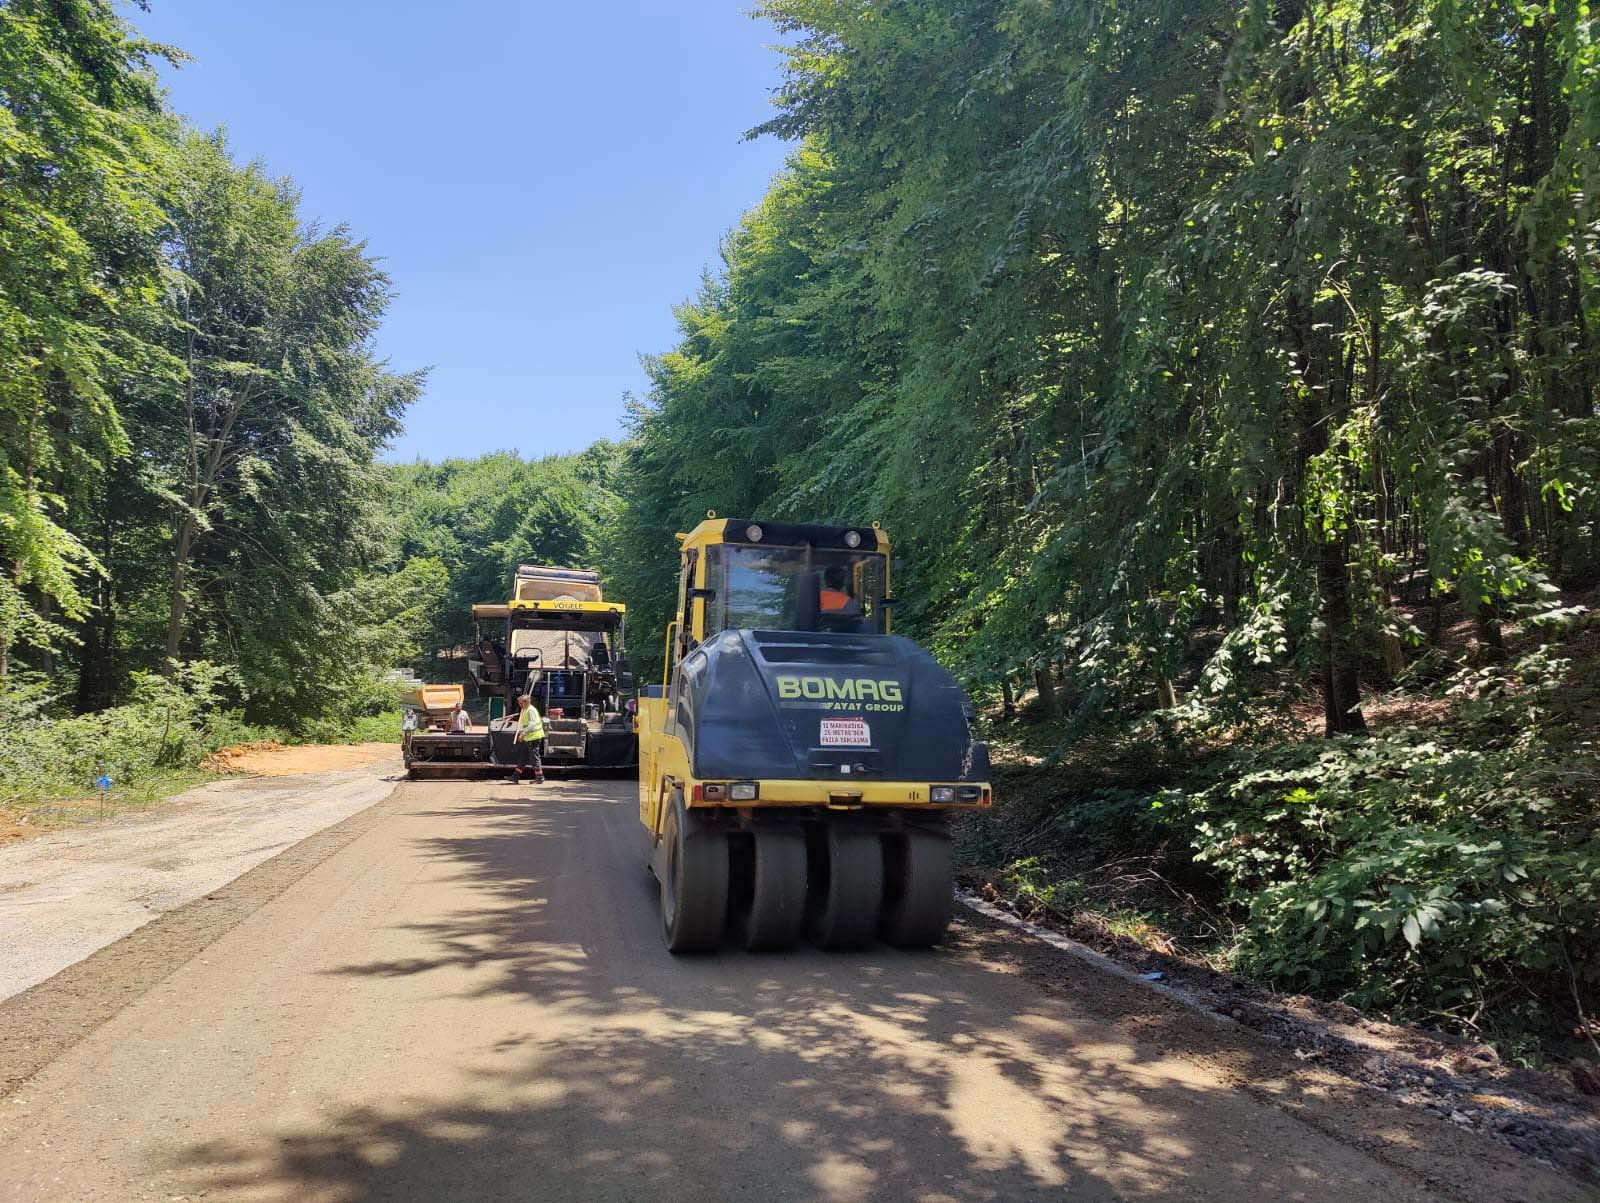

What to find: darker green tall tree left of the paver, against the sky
left=147, top=134, right=419, bottom=678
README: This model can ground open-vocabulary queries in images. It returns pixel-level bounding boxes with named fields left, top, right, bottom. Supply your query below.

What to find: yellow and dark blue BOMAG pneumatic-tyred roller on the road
left=637, top=514, right=992, bottom=952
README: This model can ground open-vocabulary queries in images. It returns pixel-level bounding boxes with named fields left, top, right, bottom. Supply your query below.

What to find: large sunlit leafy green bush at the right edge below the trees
left=1160, top=649, right=1600, bottom=1029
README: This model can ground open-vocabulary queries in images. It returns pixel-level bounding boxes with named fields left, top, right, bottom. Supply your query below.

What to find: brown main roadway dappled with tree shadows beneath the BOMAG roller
left=0, top=781, right=1584, bottom=1203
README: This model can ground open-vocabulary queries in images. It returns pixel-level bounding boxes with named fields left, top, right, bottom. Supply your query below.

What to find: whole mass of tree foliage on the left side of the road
left=0, top=0, right=425, bottom=739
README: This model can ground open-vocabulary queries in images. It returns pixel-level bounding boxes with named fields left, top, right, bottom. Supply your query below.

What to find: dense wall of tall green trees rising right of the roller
left=618, top=0, right=1600, bottom=734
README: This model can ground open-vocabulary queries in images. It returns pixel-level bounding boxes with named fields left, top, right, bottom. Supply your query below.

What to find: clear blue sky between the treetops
left=125, top=0, right=787, bottom=459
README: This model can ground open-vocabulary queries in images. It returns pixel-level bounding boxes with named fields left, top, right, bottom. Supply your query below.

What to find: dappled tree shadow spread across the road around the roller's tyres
left=171, top=790, right=1421, bottom=1200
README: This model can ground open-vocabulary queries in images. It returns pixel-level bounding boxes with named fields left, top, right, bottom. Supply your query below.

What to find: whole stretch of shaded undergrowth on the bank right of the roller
left=960, top=591, right=1600, bottom=1065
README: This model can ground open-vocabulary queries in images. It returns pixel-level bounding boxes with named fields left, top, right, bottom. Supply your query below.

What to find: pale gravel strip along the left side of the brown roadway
left=0, top=749, right=400, bottom=998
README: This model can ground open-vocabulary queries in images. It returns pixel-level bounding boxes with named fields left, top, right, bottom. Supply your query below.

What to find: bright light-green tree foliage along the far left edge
left=0, top=0, right=173, bottom=677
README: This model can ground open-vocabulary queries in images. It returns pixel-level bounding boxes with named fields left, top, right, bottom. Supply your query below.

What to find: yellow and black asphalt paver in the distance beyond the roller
left=403, top=565, right=638, bottom=777
